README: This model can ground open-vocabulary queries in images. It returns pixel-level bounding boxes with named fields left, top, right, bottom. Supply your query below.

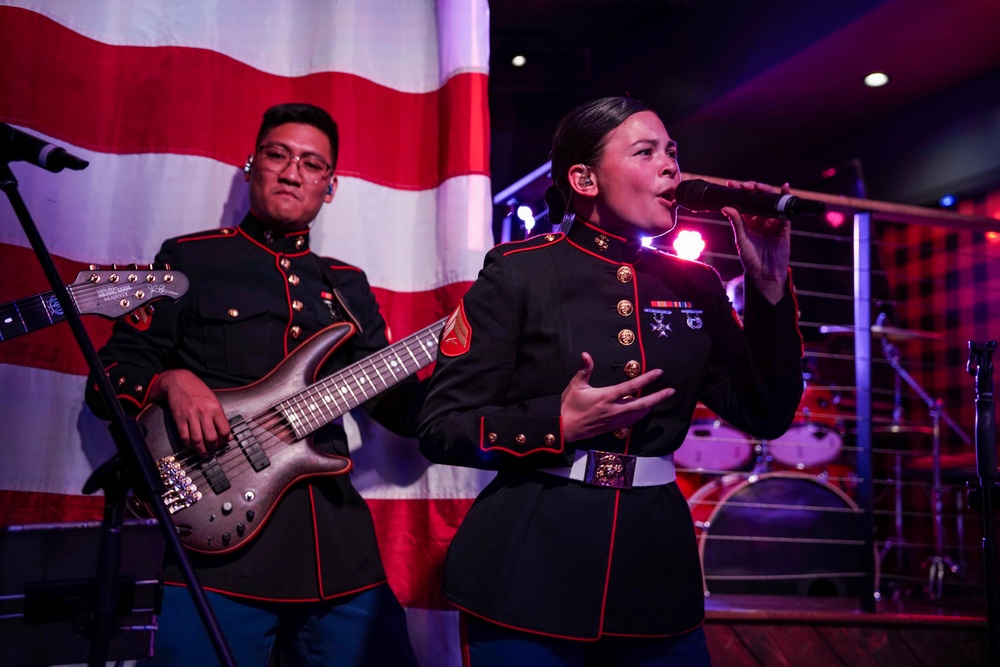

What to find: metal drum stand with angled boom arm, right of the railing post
left=882, top=336, right=971, bottom=600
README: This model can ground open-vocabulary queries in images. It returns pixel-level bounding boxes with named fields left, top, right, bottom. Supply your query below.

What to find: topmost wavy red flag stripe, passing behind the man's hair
left=0, top=7, right=489, bottom=190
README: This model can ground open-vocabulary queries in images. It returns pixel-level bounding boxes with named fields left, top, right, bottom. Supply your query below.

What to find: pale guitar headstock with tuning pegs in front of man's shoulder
left=67, top=264, right=188, bottom=319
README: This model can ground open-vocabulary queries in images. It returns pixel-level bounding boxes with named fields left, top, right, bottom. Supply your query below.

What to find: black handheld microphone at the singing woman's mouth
left=674, top=178, right=826, bottom=218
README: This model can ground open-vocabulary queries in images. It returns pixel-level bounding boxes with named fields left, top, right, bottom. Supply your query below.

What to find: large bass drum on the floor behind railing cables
left=688, top=473, right=872, bottom=596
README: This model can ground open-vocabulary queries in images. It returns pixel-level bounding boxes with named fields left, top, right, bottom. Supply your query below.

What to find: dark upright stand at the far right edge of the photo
left=966, top=340, right=1000, bottom=665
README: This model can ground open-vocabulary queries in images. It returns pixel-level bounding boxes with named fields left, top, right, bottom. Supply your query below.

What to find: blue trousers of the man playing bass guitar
left=147, top=584, right=417, bottom=667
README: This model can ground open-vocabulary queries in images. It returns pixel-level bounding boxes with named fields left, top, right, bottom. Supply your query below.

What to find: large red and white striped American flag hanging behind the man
left=0, top=0, right=492, bottom=665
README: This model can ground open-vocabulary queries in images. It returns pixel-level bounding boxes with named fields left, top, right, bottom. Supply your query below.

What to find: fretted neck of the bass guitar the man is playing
left=276, top=318, right=447, bottom=439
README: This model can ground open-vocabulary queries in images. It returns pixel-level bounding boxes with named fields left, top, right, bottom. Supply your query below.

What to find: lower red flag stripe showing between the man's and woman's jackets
left=366, top=498, right=472, bottom=609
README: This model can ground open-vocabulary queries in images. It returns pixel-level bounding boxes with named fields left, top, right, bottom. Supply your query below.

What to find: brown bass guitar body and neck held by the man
left=137, top=320, right=445, bottom=554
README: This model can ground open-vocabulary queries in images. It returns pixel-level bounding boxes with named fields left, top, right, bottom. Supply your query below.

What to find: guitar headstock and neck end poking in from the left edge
left=0, top=265, right=188, bottom=341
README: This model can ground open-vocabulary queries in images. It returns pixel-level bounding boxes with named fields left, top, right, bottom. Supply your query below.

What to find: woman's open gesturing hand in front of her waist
left=561, top=352, right=674, bottom=442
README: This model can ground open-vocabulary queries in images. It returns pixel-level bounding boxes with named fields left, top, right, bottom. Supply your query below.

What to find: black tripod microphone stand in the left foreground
left=0, top=162, right=236, bottom=667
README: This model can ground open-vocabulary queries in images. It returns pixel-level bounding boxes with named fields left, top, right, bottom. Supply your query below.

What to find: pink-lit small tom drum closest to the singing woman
left=674, top=403, right=753, bottom=474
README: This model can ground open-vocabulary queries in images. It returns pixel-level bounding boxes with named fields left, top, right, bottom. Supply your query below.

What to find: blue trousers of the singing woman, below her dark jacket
left=461, top=612, right=711, bottom=667
